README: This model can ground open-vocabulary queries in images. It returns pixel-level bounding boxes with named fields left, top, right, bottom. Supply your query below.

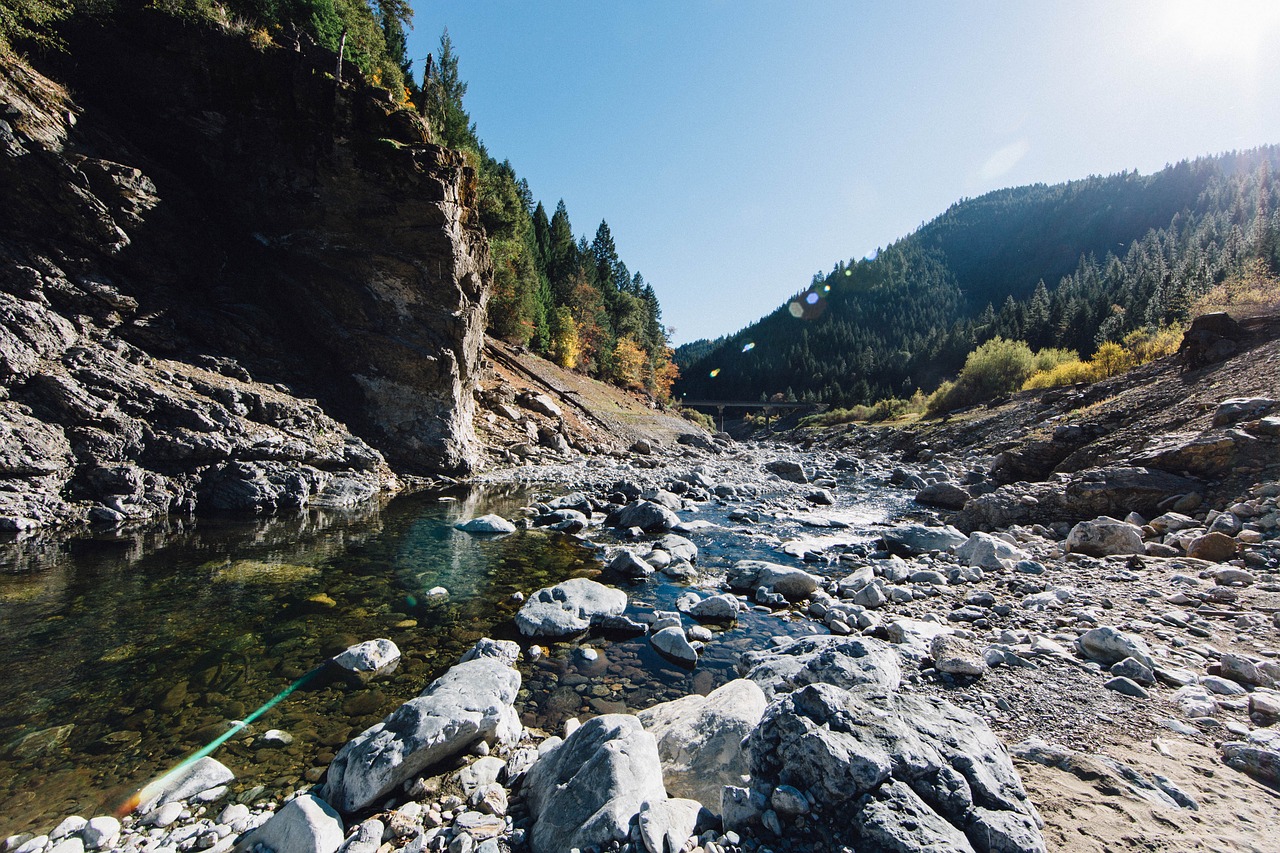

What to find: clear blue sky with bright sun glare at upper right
left=410, top=0, right=1280, bottom=343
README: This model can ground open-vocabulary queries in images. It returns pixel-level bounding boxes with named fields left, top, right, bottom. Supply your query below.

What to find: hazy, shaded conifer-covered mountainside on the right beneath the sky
left=677, top=146, right=1280, bottom=406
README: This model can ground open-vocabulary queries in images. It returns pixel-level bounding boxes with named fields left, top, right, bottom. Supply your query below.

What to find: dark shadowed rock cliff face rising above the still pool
left=0, top=15, right=490, bottom=529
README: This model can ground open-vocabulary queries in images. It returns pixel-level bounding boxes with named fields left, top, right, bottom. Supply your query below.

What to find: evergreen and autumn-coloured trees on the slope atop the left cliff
left=0, top=0, right=676, bottom=398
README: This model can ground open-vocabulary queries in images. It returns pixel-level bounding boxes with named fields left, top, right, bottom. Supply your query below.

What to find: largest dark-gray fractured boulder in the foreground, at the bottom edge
left=746, top=684, right=1044, bottom=853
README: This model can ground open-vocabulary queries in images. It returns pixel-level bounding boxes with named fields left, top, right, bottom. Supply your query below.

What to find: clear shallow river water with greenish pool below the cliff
left=0, top=488, right=892, bottom=836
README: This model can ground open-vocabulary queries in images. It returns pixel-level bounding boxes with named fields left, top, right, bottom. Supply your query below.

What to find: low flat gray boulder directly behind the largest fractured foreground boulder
left=737, top=635, right=902, bottom=699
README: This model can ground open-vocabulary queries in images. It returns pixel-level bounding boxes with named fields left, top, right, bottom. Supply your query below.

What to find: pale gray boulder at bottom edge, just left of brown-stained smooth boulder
left=524, top=713, right=667, bottom=853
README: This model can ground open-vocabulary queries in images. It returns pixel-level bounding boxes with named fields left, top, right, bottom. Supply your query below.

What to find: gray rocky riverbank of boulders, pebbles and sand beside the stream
left=6, top=404, right=1280, bottom=853
